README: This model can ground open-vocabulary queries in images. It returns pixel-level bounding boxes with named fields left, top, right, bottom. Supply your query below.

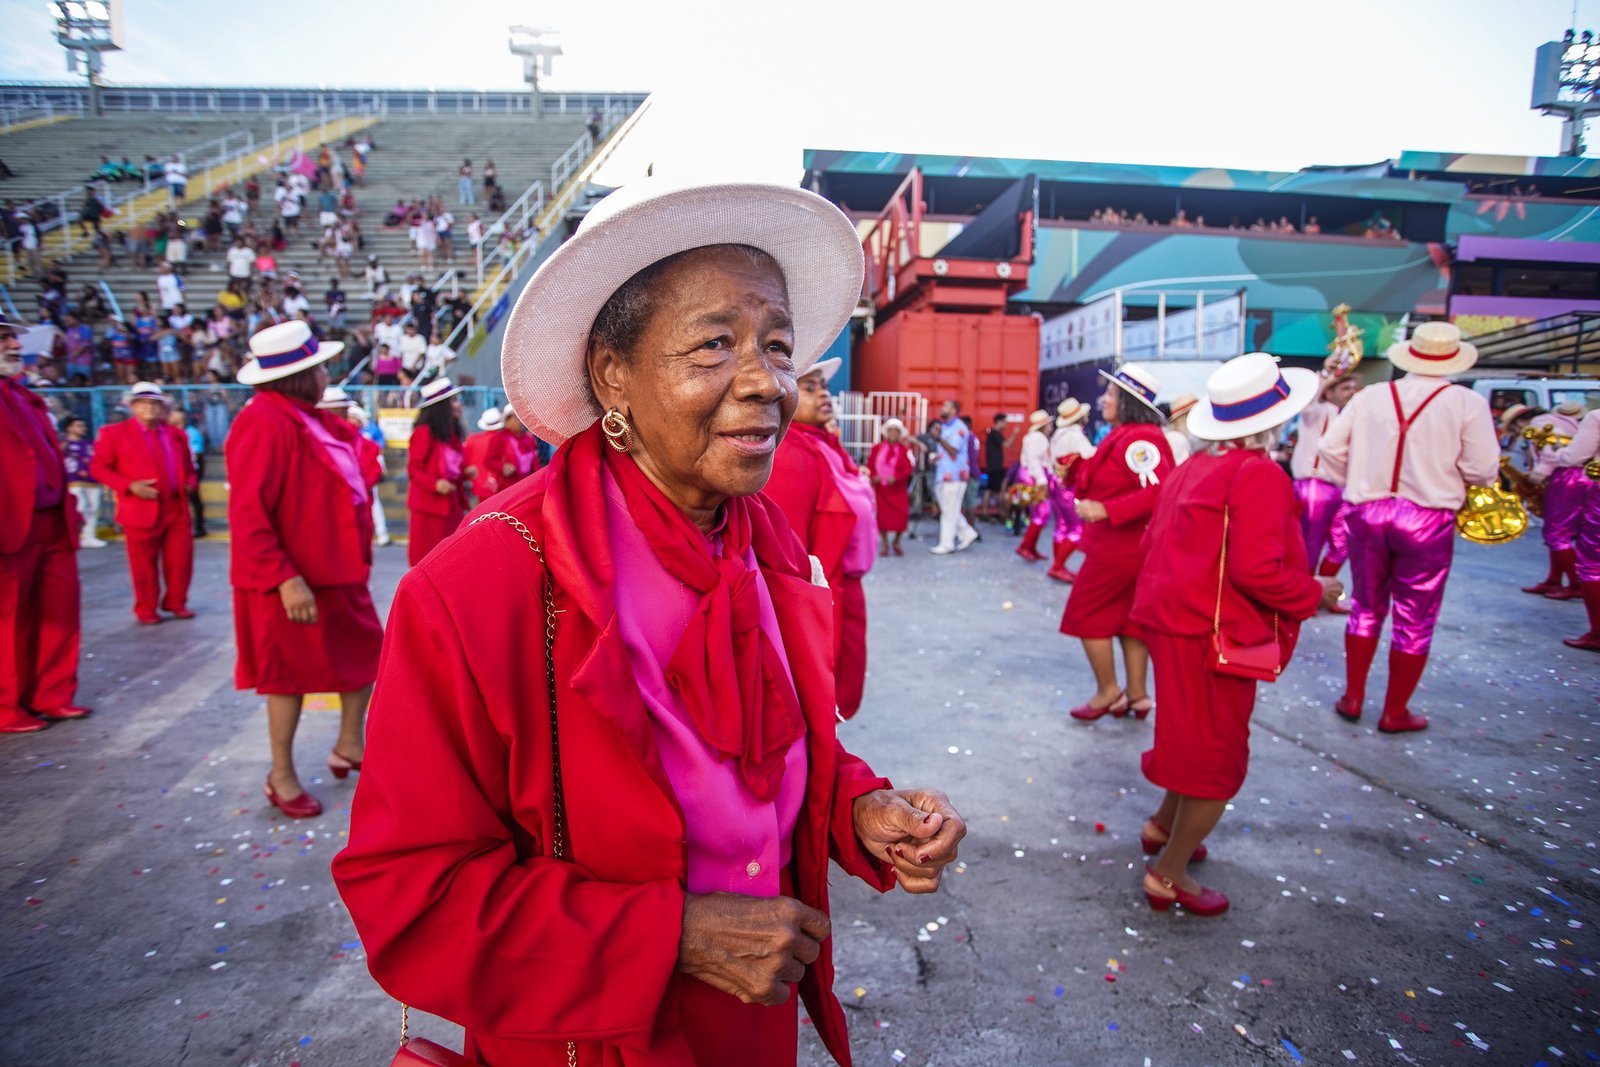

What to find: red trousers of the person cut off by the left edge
left=0, top=507, right=78, bottom=712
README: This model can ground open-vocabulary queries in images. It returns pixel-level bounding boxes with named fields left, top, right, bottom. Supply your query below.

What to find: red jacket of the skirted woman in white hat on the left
left=222, top=392, right=373, bottom=592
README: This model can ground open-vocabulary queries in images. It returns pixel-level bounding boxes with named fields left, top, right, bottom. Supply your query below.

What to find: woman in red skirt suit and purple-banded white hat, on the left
left=222, top=322, right=384, bottom=819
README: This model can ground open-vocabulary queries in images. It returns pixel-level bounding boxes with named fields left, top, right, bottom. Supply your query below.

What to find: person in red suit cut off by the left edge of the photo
left=0, top=314, right=90, bottom=734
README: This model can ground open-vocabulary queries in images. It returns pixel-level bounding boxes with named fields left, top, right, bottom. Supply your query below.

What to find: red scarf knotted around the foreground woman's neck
left=601, top=434, right=805, bottom=801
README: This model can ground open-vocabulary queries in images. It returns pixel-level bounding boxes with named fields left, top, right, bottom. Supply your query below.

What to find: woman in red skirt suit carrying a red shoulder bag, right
left=1133, top=352, right=1342, bottom=915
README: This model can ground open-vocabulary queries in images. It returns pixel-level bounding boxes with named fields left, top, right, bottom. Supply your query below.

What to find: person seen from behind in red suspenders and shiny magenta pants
left=1318, top=323, right=1499, bottom=733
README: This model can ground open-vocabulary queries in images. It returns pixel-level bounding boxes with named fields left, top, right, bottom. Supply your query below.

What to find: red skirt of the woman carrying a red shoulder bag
left=1141, top=630, right=1256, bottom=800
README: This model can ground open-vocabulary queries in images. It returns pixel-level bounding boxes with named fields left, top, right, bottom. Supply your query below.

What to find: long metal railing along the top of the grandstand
left=0, top=82, right=648, bottom=115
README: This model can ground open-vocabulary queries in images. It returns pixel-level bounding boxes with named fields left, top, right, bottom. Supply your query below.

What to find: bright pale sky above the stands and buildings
left=0, top=0, right=1600, bottom=181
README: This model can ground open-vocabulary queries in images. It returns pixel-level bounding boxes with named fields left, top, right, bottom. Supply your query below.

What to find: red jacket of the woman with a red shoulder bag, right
left=1133, top=448, right=1322, bottom=665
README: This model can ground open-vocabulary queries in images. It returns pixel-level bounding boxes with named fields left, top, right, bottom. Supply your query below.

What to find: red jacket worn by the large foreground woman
left=333, top=445, right=893, bottom=1067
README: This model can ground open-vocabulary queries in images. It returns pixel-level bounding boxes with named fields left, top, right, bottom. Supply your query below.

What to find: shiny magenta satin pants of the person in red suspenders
left=1346, top=498, right=1459, bottom=656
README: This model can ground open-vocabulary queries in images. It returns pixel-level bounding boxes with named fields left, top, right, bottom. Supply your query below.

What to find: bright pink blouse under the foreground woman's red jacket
left=603, top=472, right=808, bottom=896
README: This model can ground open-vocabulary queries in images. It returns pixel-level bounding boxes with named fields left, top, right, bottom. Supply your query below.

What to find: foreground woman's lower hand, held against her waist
left=678, top=893, right=834, bottom=1008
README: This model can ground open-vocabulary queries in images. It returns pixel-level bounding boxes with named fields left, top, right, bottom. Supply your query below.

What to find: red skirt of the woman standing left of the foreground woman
left=234, top=584, right=384, bottom=694
